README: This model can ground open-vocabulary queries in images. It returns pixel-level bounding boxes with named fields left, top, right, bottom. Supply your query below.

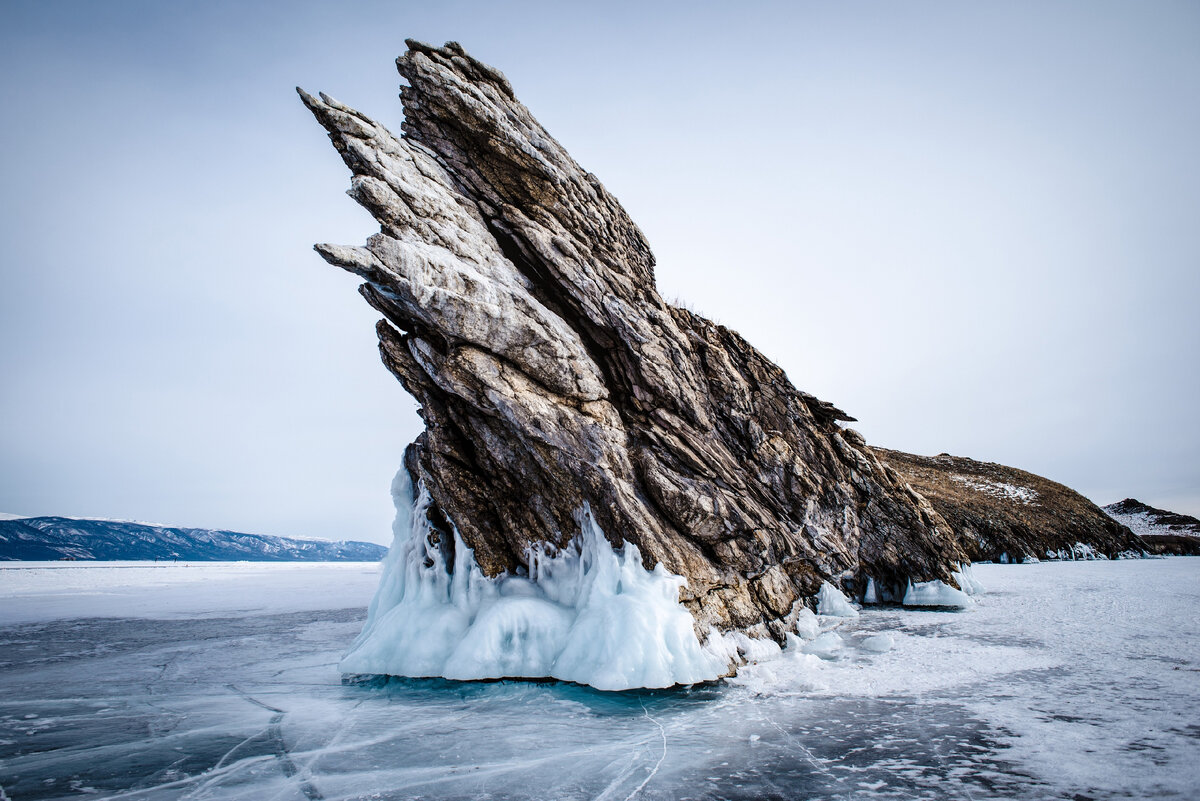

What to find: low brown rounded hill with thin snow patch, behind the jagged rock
left=872, top=447, right=1150, bottom=561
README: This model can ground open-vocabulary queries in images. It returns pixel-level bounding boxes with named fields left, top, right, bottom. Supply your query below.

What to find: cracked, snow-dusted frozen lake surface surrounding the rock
left=0, top=558, right=1200, bottom=801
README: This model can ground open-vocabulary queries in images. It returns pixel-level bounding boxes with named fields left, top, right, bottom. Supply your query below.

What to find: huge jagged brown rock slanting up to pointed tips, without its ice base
left=301, top=41, right=967, bottom=637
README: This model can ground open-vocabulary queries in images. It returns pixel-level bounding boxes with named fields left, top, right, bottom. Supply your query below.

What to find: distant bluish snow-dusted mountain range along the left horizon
left=0, top=517, right=388, bottom=562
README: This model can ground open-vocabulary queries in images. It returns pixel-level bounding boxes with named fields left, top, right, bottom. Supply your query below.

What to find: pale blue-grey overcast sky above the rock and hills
left=0, top=0, right=1200, bottom=542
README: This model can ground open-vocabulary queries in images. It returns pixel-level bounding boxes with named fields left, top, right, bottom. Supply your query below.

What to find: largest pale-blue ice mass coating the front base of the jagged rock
left=340, top=469, right=728, bottom=689
